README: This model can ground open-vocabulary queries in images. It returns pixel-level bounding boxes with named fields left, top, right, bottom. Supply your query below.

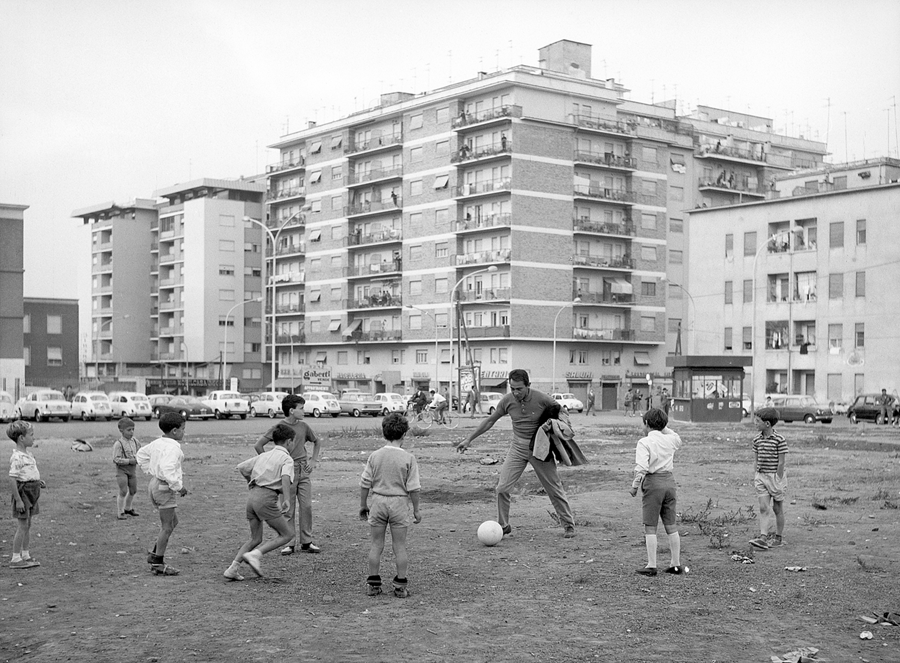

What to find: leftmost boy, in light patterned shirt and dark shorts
left=6, top=421, right=46, bottom=569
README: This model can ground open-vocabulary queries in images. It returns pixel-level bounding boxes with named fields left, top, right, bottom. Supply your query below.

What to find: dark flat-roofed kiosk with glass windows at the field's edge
left=666, top=355, right=753, bottom=422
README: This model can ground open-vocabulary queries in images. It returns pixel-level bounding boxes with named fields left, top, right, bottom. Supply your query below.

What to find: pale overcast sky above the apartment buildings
left=0, top=0, right=900, bottom=298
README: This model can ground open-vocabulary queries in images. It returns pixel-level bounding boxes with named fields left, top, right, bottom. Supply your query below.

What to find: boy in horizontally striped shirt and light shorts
left=750, top=407, right=787, bottom=550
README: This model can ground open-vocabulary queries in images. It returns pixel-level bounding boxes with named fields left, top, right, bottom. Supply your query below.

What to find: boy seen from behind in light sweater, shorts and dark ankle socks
left=359, top=412, right=422, bottom=599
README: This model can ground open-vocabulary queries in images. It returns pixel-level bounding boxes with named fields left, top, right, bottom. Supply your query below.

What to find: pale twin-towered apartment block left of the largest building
left=73, top=178, right=268, bottom=394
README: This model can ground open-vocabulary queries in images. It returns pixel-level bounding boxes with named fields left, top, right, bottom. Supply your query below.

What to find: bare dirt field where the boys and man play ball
left=0, top=417, right=900, bottom=663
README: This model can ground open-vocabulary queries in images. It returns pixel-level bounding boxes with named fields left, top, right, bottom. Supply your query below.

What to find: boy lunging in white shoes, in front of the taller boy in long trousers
left=223, top=424, right=294, bottom=580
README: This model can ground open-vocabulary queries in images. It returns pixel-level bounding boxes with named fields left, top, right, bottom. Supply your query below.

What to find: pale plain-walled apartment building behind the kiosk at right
left=689, top=158, right=900, bottom=402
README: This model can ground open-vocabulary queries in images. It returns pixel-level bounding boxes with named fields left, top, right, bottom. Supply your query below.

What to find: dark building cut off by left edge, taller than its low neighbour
left=0, top=203, right=28, bottom=401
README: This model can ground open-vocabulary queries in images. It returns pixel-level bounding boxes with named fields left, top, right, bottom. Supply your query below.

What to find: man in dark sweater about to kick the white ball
left=456, top=368, right=575, bottom=539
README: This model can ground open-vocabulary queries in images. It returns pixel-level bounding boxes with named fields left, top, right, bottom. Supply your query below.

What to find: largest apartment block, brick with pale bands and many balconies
left=267, top=41, right=824, bottom=408
